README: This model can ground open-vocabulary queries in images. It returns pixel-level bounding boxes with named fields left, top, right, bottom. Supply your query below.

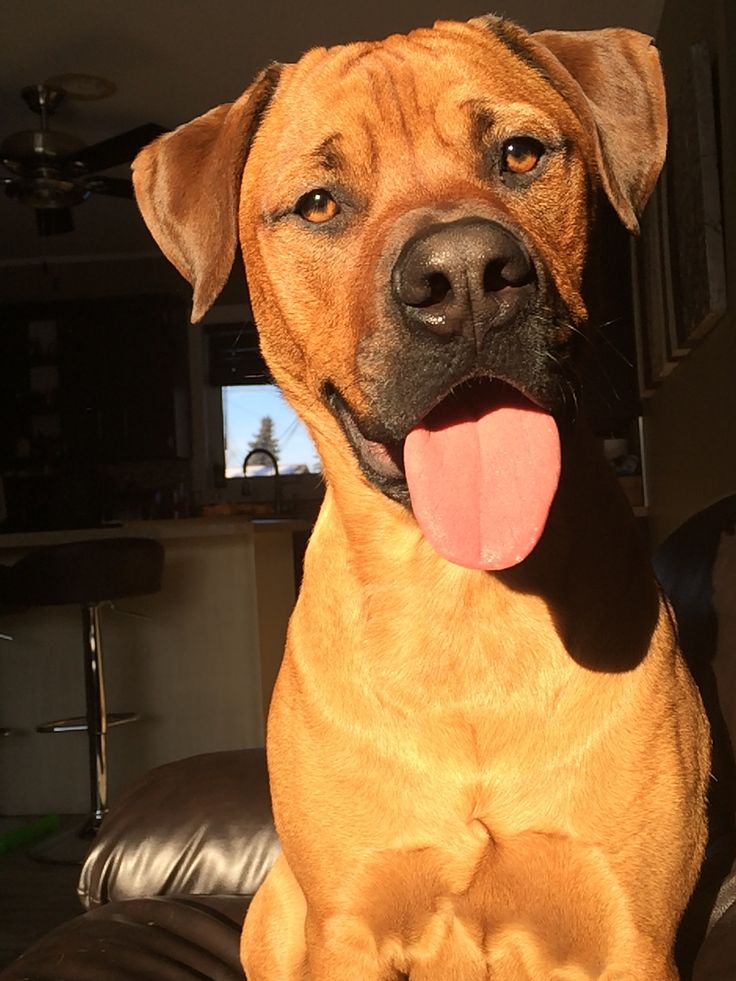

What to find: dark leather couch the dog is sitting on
left=0, top=496, right=736, bottom=981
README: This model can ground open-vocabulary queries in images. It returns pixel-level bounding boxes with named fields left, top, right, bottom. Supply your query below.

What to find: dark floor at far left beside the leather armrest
left=0, top=820, right=83, bottom=968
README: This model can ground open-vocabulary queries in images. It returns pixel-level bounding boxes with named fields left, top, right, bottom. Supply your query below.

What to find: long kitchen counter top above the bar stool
left=0, top=515, right=310, bottom=549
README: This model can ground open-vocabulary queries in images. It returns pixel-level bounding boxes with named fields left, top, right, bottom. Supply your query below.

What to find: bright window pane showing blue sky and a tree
left=222, top=385, right=321, bottom=477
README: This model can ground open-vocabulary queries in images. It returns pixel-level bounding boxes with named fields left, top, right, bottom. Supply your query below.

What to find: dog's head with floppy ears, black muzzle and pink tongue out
left=134, top=17, right=666, bottom=568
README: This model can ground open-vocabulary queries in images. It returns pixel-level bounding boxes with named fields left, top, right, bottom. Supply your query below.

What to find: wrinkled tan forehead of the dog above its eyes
left=254, top=22, right=574, bottom=180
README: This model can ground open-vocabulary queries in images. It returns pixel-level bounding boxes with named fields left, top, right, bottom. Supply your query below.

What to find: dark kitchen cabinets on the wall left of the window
left=0, top=296, right=190, bottom=470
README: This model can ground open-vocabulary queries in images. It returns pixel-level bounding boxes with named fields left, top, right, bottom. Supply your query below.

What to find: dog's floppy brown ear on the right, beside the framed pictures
left=530, top=28, right=667, bottom=232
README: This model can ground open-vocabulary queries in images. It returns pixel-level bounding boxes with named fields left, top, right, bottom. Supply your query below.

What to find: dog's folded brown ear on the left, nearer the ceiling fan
left=133, top=64, right=281, bottom=322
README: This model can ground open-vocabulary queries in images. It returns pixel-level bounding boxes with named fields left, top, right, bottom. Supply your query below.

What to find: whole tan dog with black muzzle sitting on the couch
left=135, top=17, right=709, bottom=981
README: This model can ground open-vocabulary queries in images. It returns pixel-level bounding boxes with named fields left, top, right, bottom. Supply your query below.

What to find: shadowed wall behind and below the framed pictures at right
left=644, top=0, right=736, bottom=544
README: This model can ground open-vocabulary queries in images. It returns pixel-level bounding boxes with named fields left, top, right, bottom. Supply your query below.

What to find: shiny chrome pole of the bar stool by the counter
left=82, top=603, right=107, bottom=837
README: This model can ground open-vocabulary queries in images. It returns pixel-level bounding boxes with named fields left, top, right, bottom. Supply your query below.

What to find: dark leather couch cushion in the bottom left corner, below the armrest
left=0, top=896, right=248, bottom=981
